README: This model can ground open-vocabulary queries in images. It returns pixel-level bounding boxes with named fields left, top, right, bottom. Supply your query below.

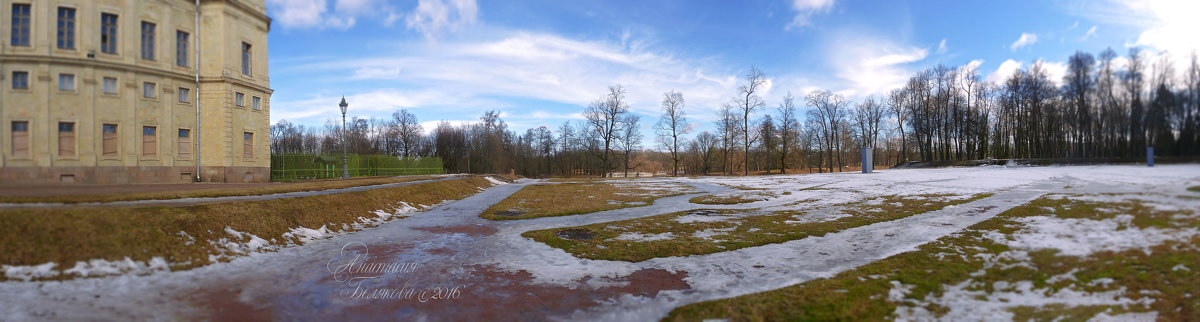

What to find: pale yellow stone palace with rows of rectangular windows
left=0, top=0, right=271, bottom=185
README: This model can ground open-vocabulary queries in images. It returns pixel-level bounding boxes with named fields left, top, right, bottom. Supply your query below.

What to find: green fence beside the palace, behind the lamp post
left=271, top=154, right=443, bottom=181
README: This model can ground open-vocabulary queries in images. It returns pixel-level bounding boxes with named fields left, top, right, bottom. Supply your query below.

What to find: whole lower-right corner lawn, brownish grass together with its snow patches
left=668, top=193, right=1200, bottom=321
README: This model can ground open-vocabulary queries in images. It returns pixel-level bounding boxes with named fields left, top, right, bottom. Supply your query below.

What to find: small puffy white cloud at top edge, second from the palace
left=406, top=0, right=479, bottom=41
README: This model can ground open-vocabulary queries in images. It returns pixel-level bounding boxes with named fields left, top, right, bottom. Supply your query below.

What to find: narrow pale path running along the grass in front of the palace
left=0, top=177, right=464, bottom=209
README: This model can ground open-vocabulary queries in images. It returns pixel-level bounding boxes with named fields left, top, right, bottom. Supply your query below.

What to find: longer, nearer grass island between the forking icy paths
left=521, top=193, right=990, bottom=262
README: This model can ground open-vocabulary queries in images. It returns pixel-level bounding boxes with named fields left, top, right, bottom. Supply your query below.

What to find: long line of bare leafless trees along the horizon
left=271, top=48, right=1200, bottom=175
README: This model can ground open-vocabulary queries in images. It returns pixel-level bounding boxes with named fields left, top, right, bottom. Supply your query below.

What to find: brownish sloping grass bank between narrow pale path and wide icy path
left=0, top=177, right=491, bottom=279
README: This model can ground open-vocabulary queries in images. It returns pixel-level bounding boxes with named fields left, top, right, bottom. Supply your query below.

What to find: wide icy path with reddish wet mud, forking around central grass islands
left=0, top=167, right=1190, bottom=321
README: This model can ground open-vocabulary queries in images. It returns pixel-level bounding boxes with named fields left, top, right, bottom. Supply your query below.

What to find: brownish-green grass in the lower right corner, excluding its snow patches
left=666, top=197, right=1200, bottom=321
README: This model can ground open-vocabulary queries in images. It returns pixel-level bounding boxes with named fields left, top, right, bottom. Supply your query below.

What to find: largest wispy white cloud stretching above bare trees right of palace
left=271, top=32, right=742, bottom=125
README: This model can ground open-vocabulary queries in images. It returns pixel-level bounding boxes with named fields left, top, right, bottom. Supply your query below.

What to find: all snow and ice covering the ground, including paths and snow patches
left=0, top=165, right=1200, bottom=321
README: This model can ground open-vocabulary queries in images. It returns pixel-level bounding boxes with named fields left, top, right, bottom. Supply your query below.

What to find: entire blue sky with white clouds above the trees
left=266, top=0, right=1200, bottom=135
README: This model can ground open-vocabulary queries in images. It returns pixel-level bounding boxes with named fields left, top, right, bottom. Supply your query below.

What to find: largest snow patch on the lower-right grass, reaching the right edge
left=984, top=215, right=1200, bottom=256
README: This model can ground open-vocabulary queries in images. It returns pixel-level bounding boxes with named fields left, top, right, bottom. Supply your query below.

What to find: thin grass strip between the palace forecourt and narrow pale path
left=0, top=177, right=436, bottom=203
